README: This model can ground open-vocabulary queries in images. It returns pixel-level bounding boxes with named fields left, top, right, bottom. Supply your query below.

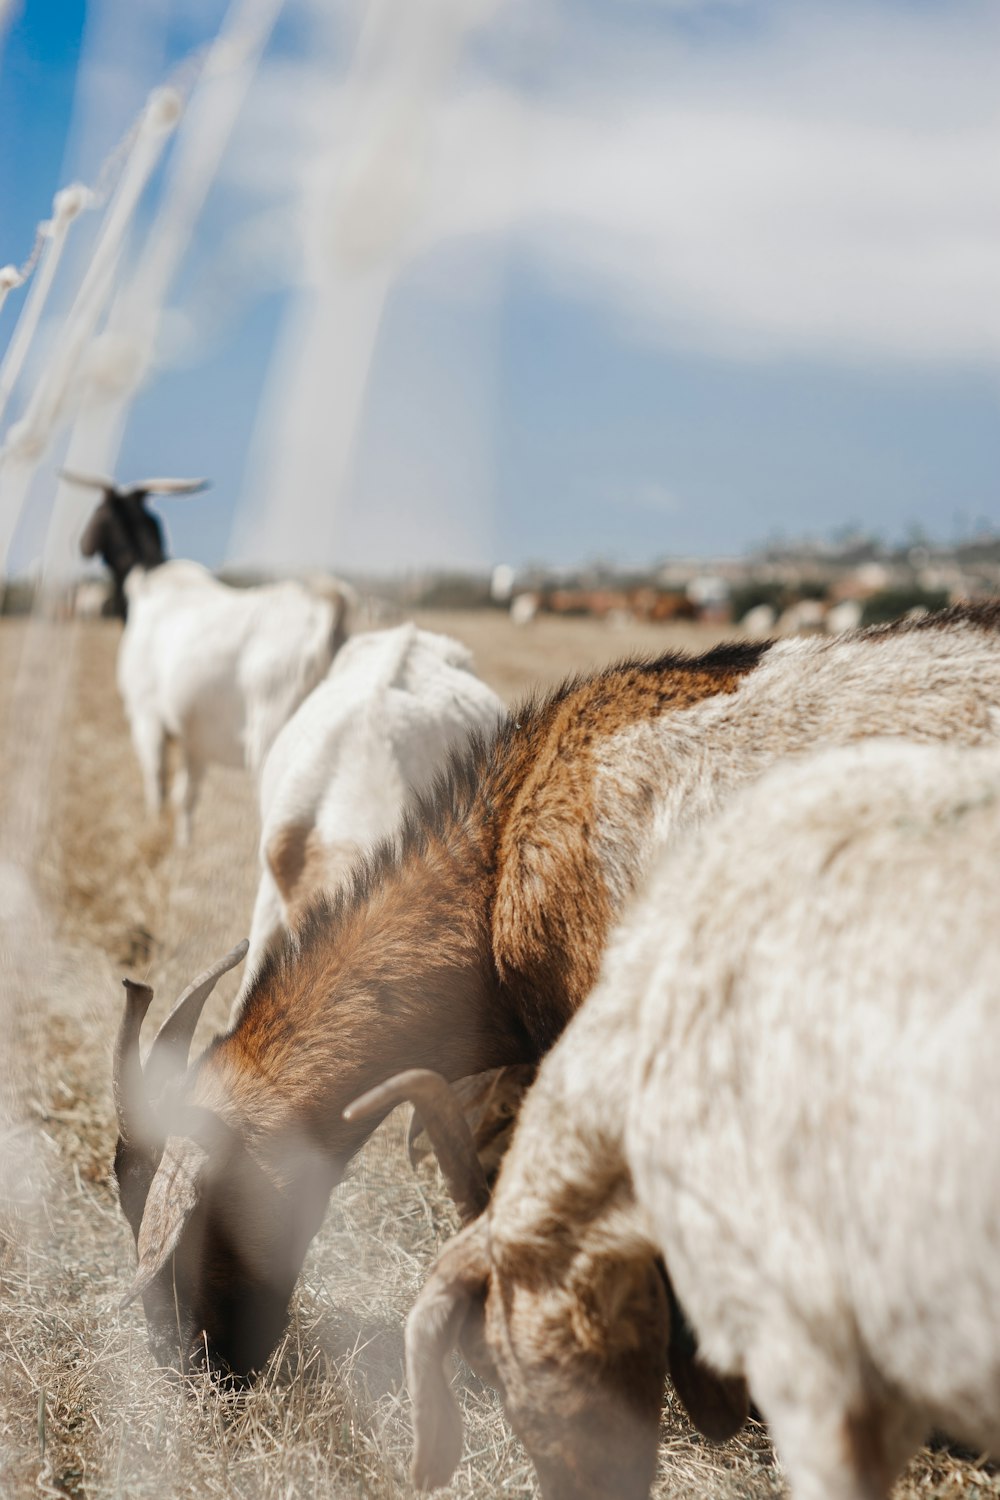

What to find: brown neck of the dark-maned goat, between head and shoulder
left=209, top=822, right=531, bottom=1170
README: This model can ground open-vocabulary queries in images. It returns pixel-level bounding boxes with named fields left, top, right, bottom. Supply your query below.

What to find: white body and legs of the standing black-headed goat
left=118, top=561, right=346, bottom=845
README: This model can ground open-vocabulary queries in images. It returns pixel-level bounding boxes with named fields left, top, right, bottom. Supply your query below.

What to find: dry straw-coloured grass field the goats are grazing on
left=0, top=615, right=1000, bottom=1500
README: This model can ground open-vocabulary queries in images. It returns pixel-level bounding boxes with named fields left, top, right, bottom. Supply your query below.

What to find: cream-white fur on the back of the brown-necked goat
left=595, top=626, right=1000, bottom=909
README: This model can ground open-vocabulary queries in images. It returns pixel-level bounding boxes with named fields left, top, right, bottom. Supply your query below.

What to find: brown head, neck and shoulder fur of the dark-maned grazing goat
left=117, top=605, right=1000, bottom=1374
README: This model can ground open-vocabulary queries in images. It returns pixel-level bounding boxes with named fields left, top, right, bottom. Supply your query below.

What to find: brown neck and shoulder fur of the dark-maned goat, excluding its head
left=196, top=647, right=766, bottom=1161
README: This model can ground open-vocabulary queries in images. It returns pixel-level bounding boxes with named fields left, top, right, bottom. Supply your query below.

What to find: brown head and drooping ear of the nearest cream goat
left=406, top=1217, right=669, bottom=1500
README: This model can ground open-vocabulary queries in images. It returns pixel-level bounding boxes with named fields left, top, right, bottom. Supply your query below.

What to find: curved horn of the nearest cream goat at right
left=343, top=1068, right=490, bottom=1224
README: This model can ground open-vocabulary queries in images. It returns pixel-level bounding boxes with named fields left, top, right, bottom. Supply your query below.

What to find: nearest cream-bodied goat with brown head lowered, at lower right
left=395, top=741, right=1000, bottom=1500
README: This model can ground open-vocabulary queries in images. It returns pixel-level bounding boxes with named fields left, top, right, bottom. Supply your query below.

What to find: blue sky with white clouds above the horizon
left=0, top=0, right=1000, bottom=570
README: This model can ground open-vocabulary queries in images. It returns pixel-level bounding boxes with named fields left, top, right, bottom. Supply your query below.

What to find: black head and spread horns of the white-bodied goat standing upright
left=63, top=470, right=207, bottom=620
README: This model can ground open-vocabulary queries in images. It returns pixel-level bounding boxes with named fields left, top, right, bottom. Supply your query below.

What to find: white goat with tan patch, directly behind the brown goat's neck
left=234, top=624, right=504, bottom=996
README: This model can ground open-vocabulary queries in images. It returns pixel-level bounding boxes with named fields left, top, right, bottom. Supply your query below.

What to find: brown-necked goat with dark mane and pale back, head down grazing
left=117, top=605, right=1000, bottom=1371
